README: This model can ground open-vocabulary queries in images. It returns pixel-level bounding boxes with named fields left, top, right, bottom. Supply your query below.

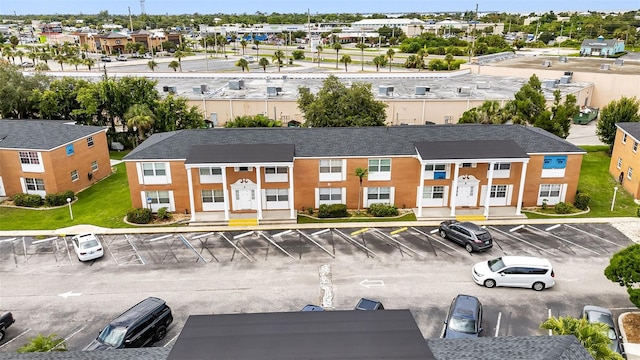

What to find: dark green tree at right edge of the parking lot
left=604, top=244, right=640, bottom=307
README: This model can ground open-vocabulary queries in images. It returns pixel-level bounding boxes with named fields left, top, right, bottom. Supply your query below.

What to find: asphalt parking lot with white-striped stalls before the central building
left=0, top=224, right=632, bottom=352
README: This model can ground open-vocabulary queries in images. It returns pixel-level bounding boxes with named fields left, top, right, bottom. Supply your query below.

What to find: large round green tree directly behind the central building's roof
left=298, top=75, right=387, bottom=127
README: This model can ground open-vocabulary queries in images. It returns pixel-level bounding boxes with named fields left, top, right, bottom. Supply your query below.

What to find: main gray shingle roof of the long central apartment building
left=125, top=124, right=584, bottom=160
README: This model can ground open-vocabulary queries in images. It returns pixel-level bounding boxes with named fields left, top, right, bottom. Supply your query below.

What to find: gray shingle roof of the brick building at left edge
left=0, top=120, right=106, bottom=150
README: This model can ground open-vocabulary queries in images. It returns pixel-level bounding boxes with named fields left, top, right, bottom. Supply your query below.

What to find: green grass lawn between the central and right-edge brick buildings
left=526, top=146, right=638, bottom=219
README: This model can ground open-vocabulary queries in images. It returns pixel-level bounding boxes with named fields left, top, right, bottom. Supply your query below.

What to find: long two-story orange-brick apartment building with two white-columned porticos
left=124, top=124, right=584, bottom=222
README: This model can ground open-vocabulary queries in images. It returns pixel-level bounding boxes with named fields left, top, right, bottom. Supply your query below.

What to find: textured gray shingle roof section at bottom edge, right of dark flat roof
left=427, top=335, right=593, bottom=360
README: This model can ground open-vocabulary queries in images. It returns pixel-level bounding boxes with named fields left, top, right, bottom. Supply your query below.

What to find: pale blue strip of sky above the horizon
left=0, top=0, right=640, bottom=15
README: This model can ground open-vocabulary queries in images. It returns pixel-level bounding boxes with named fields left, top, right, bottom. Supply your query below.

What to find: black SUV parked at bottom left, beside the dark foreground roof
left=84, top=297, right=173, bottom=350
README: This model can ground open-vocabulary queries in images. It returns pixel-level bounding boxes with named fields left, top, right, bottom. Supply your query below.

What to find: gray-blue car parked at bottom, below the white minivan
left=443, top=295, right=482, bottom=339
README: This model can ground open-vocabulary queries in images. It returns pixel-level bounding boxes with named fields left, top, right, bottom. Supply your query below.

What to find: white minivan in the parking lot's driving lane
left=471, top=256, right=555, bottom=291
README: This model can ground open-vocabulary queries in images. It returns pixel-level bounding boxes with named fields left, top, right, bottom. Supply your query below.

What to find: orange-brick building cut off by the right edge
left=609, top=122, right=640, bottom=199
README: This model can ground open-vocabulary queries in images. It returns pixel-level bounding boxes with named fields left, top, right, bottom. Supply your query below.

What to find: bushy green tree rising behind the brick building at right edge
left=596, top=96, right=640, bottom=146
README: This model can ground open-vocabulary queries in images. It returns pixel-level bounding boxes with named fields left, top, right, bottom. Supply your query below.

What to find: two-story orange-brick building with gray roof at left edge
left=0, top=120, right=111, bottom=197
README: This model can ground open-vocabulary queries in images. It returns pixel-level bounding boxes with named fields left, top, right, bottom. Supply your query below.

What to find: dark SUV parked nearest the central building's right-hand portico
left=438, top=220, right=493, bottom=252
